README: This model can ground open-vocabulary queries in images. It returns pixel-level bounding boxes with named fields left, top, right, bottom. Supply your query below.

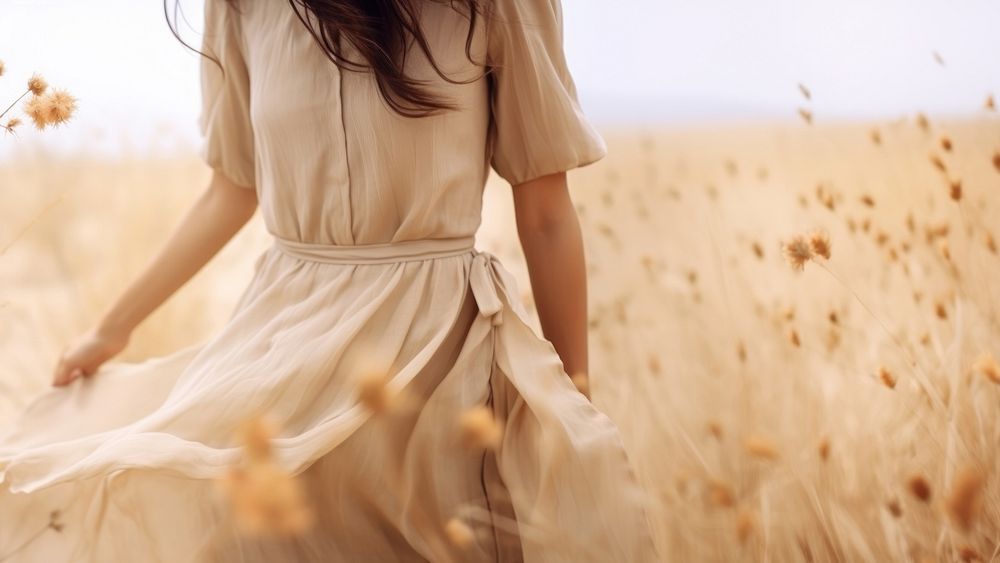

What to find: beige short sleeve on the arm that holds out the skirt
left=199, top=0, right=256, bottom=188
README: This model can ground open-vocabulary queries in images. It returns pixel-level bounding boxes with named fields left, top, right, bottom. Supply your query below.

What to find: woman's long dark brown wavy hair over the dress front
left=163, top=0, right=490, bottom=117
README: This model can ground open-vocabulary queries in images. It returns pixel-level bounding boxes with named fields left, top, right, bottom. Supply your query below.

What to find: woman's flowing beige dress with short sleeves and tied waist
left=0, top=0, right=656, bottom=563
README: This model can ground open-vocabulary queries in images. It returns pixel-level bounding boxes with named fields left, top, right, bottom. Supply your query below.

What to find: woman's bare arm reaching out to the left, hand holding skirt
left=52, top=172, right=257, bottom=386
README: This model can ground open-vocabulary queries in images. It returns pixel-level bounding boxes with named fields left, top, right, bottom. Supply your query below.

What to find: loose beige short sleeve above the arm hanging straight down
left=487, top=0, right=607, bottom=185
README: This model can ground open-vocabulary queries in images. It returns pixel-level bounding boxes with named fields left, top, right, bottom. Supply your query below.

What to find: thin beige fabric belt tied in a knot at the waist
left=274, top=236, right=504, bottom=326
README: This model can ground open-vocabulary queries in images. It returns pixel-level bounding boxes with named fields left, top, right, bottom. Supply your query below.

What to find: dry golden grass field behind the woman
left=0, top=117, right=1000, bottom=562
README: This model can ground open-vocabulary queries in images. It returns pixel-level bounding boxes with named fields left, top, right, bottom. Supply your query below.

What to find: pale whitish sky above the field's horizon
left=0, top=0, right=1000, bottom=155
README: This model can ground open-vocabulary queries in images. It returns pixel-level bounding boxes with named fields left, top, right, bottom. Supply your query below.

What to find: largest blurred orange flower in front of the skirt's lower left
left=220, top=417, right=314, bottom=536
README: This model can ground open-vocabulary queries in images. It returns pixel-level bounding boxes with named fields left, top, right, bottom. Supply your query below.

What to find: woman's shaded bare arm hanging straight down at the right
left=513, top=172, right=589, bottom=397
